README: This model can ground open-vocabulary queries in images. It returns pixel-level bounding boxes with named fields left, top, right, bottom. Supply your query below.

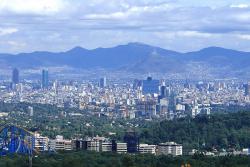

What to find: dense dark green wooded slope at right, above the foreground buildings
left=140, top=112, right=250, bottom=150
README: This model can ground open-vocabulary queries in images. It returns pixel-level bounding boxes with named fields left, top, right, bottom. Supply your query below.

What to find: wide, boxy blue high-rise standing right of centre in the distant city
left=142, top=77, right=160, bottom=95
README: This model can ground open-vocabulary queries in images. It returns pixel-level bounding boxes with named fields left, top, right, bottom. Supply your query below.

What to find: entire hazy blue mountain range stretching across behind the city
left=0, top=43, right=250, bottom=76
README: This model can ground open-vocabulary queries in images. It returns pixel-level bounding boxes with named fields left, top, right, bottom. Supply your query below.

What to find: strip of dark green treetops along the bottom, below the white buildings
left=0, top=152, right=250, bottom=167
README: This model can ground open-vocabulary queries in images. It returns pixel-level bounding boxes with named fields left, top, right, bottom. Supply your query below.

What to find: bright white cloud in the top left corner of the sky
left=0, top=0, right=66, bottom=15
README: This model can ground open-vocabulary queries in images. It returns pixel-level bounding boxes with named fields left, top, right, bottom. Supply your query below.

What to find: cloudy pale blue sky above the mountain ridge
left=0, top=0, right=250, bottom=53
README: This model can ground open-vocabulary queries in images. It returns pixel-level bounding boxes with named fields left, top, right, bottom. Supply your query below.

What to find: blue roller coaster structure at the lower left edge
left=0, top=125, right=35, bottom=156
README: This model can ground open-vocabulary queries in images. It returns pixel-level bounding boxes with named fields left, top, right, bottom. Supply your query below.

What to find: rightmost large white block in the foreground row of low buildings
left=157, top=142, right=182, bottom=156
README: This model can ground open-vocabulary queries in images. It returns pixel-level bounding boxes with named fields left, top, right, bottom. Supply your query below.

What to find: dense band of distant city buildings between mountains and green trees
left=0, top=68, right=250, bottom=120
